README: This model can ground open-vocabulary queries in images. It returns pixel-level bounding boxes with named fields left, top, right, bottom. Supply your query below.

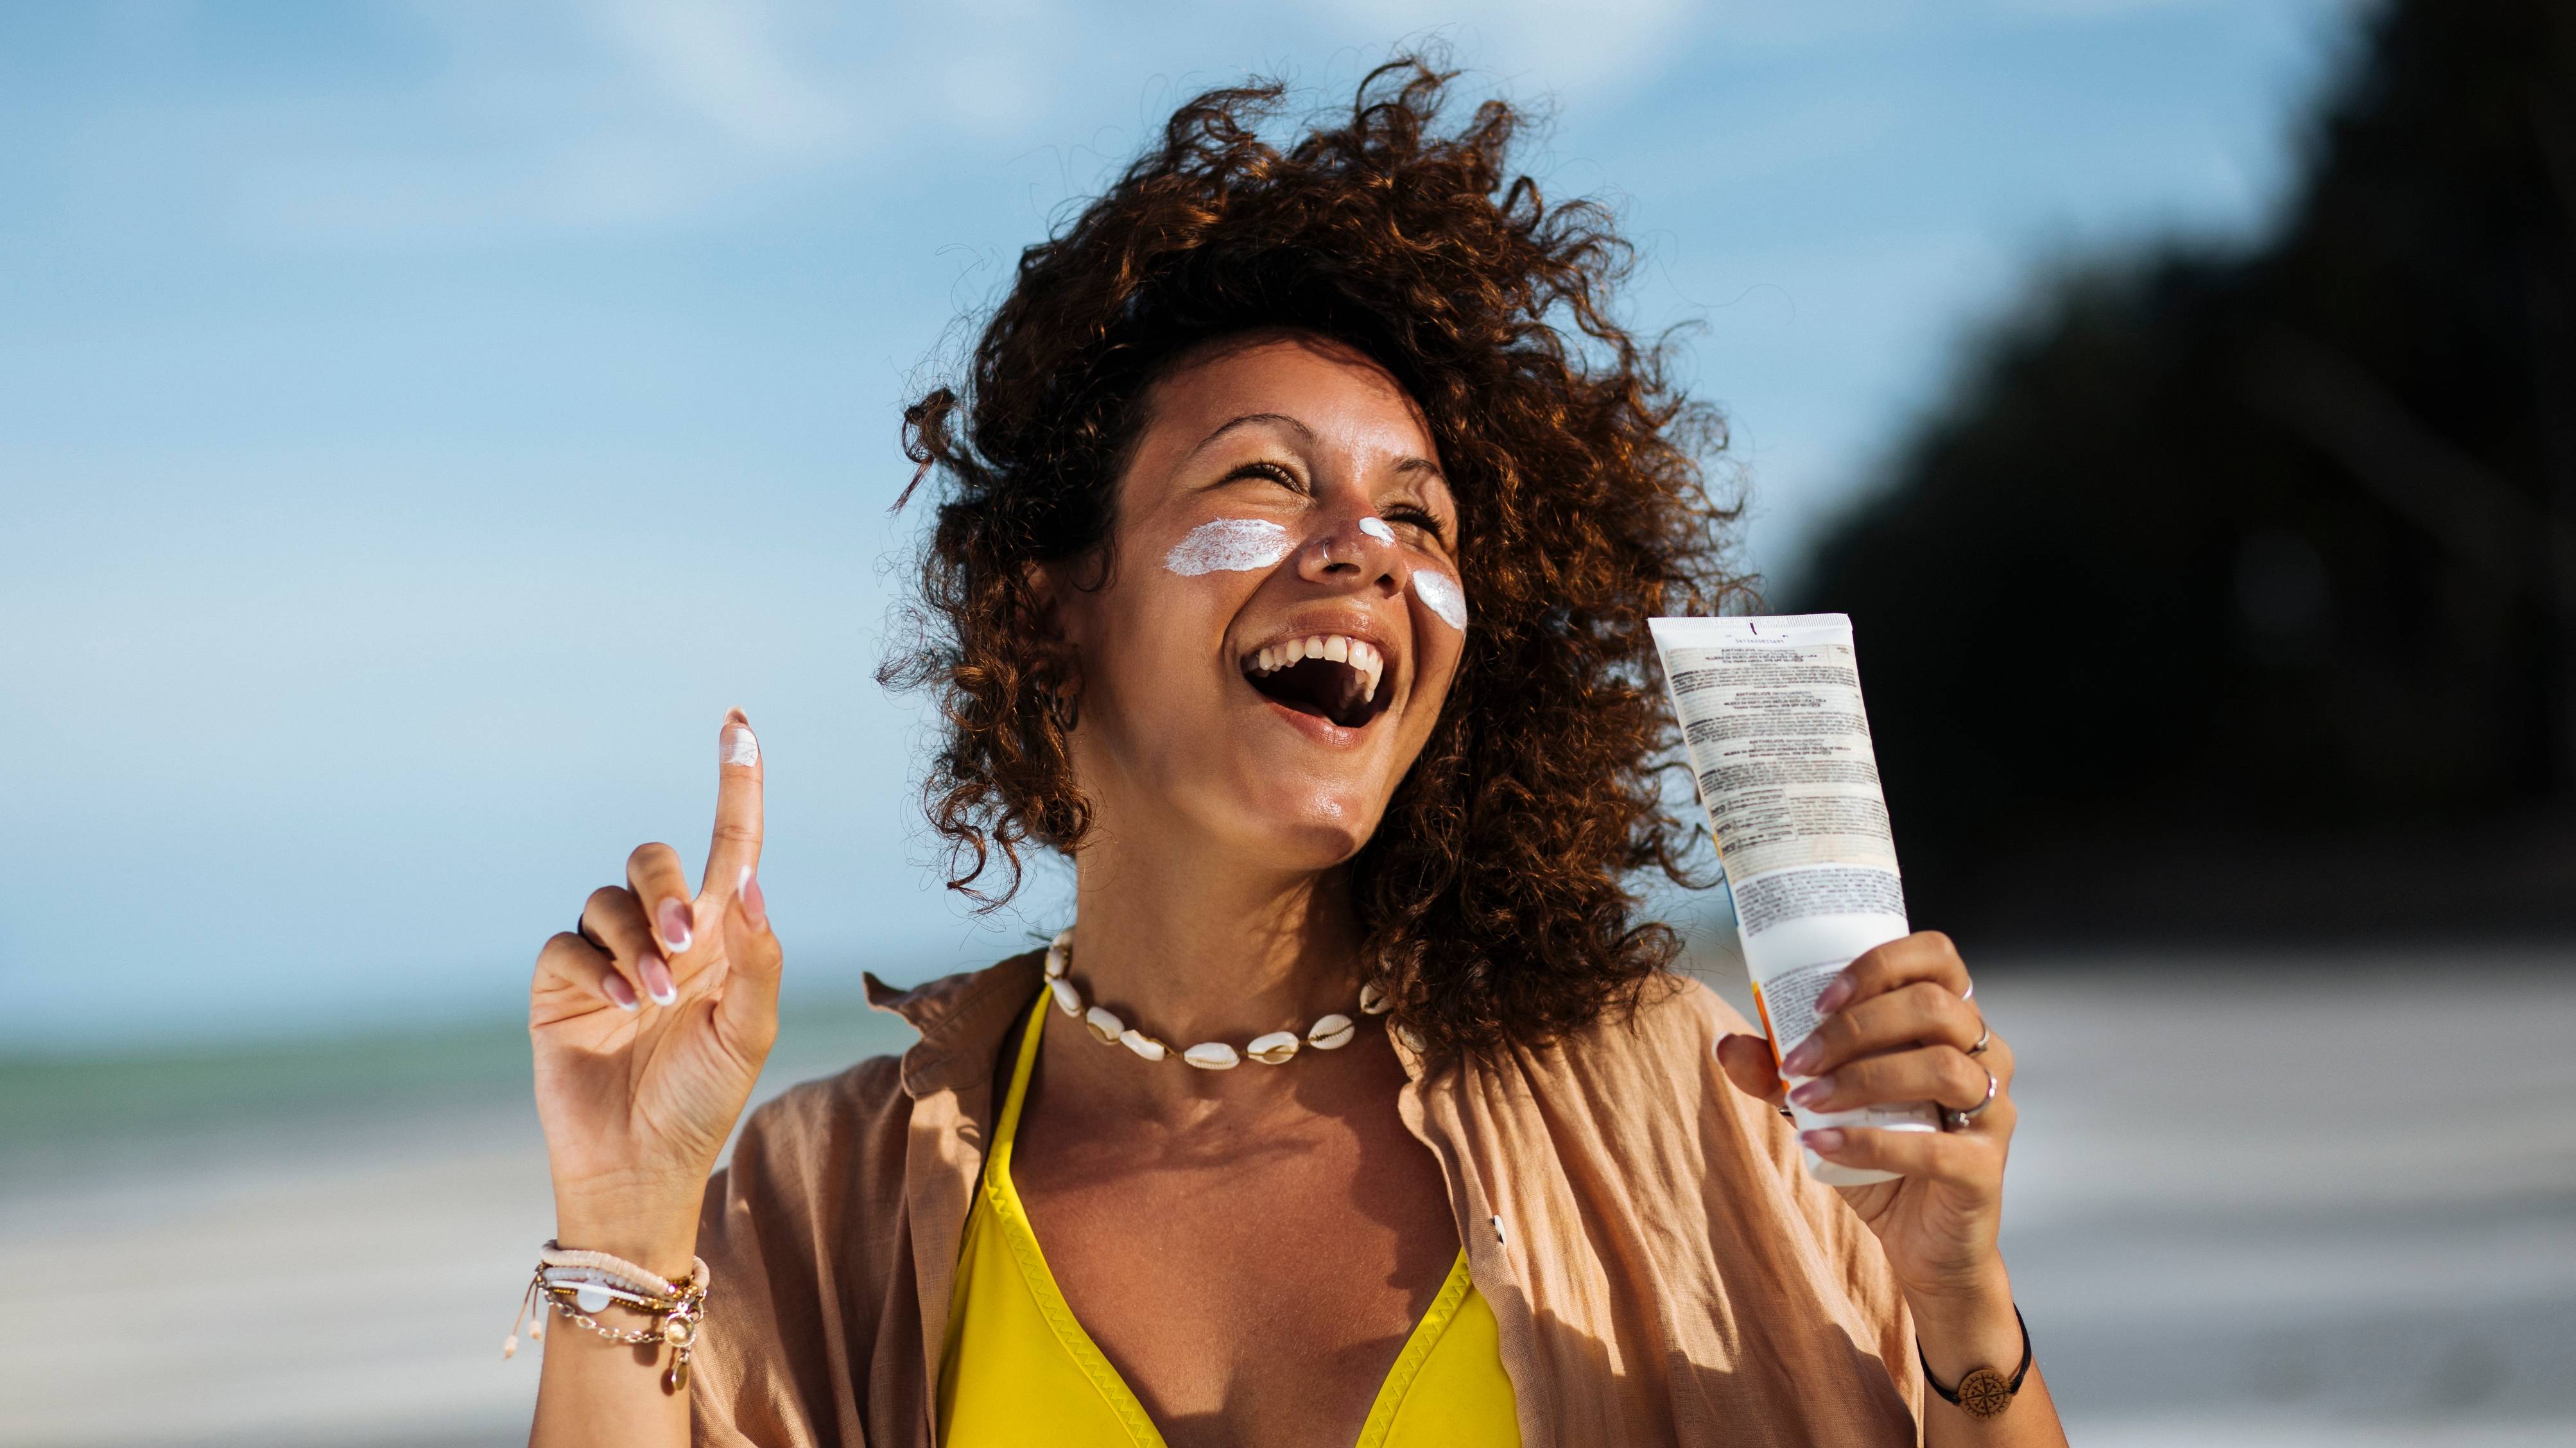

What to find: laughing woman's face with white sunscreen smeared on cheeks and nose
left=1051, top=332, right=1468, bottom=871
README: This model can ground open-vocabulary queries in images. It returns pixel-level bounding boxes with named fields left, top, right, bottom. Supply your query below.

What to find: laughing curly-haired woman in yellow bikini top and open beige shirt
left=531, top=62, right=2061, bottom=1448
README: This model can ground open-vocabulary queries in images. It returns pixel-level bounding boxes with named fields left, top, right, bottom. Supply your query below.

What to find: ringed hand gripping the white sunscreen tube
left=1718, top=930, right=2014, bottom=1314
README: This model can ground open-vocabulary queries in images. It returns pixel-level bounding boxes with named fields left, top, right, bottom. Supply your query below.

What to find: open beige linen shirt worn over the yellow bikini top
left=690, top=953, right=1922, bottom=1448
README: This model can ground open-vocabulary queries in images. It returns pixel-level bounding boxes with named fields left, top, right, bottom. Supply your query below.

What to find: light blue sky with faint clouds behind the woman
left=0, top=0, right=2355, bottom=1046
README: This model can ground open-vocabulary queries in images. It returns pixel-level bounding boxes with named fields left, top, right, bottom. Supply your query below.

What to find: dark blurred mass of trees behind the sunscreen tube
left=1783, top=0, right=2576, bottom=933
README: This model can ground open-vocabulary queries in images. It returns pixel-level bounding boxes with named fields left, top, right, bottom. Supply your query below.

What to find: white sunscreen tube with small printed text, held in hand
left=1648, top=613, right=1940, bottom=1185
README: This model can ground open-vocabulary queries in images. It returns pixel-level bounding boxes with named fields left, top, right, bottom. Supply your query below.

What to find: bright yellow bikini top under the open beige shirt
left=940, top=992, right=1520, bottom=1448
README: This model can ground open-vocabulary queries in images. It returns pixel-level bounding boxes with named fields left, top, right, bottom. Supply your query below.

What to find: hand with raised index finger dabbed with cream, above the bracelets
left=528, top=709, right=781, bottom=1275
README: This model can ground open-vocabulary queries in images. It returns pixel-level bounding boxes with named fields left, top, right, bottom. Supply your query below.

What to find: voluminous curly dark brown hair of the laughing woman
left=878, top=56, right=1744, bottom=1051
